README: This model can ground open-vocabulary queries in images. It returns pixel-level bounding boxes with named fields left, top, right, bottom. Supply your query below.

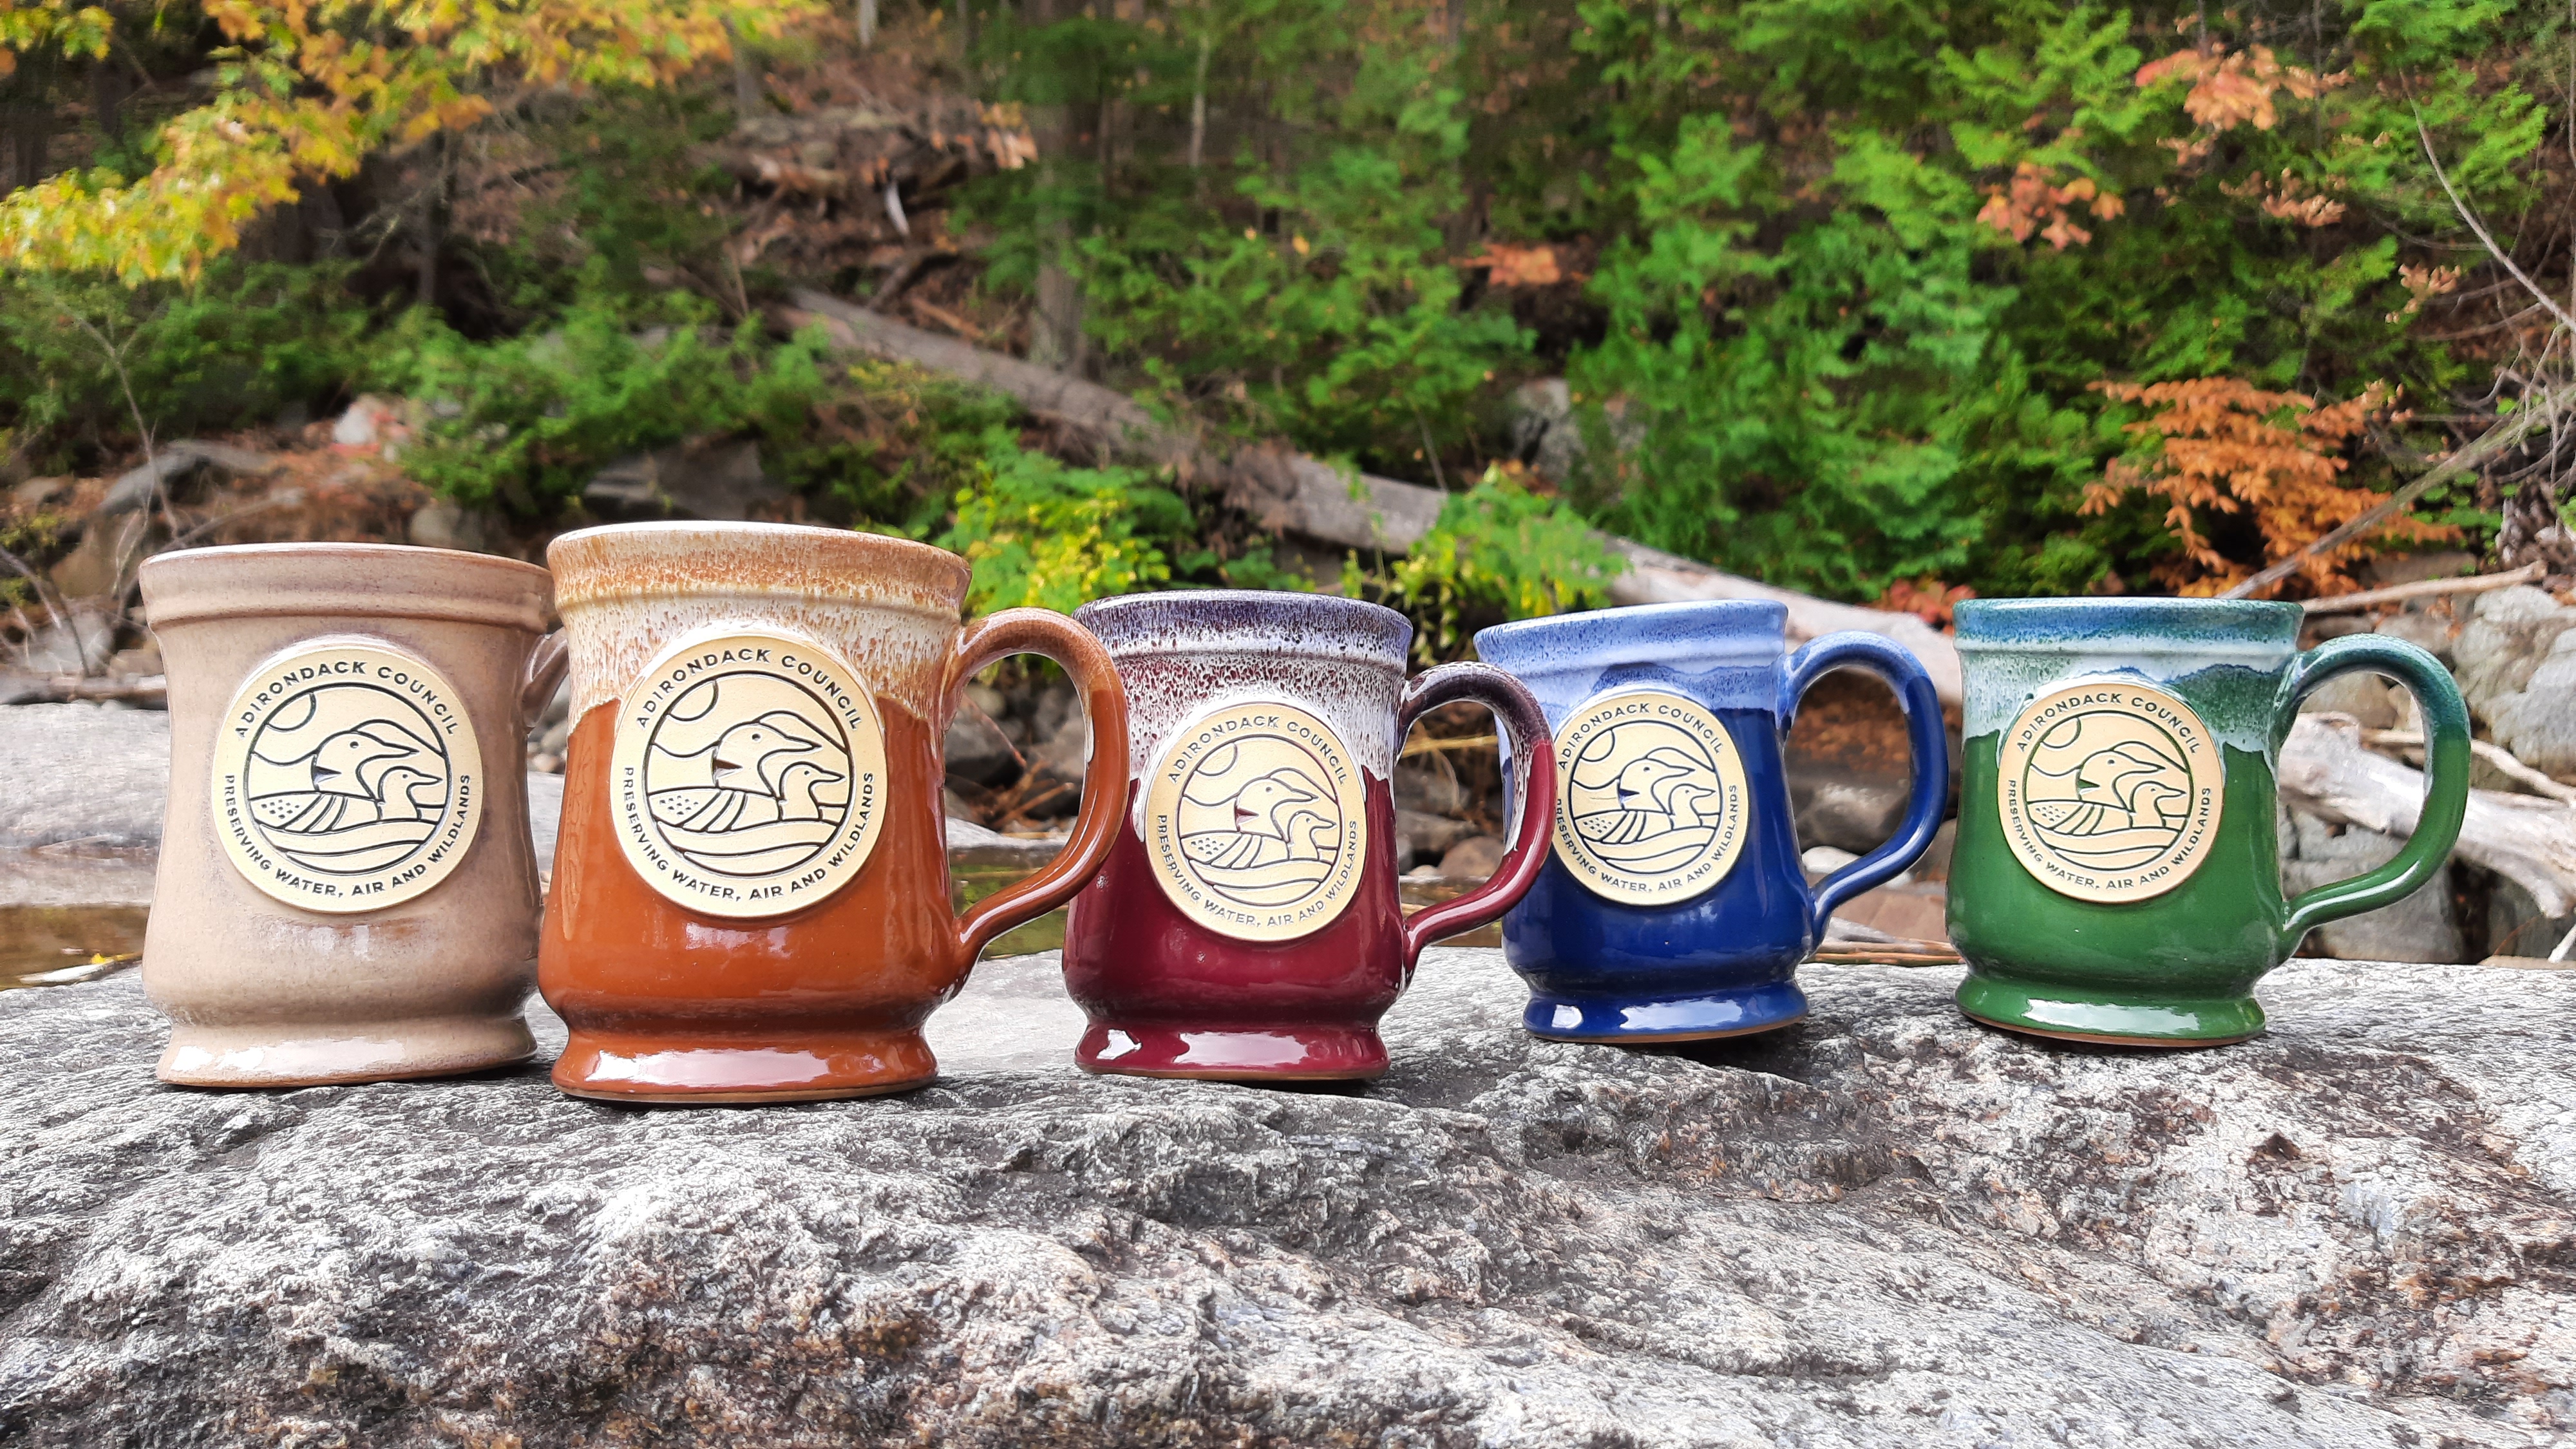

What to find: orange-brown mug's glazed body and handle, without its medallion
left=541, top=526, right=1126, bottom=1101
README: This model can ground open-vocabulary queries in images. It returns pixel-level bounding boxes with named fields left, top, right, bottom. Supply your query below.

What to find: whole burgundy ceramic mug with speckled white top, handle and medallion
left=1064, top=591, right=1553, bottom=1080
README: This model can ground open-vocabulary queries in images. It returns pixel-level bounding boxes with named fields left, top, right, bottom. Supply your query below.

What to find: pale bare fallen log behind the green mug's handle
left=2280, top=714, right=2576, bottom=920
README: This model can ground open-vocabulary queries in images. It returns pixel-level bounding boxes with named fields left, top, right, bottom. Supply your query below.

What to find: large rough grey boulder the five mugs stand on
left=0, top=951, right=2576, bottom=1449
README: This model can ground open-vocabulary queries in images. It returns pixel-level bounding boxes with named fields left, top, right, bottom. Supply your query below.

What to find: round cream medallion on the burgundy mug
left=1144, top=704, right=1368, bottom=941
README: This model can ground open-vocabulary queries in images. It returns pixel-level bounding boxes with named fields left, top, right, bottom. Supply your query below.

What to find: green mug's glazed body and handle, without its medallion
left=1950, top=598, right=2468, bottom=1046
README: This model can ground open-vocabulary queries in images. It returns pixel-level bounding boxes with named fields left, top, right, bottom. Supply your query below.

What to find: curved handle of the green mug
left=2264, top=634, right=2468, bottom=956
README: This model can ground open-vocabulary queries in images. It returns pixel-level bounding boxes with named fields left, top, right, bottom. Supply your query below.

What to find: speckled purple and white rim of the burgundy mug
left=1074, top=588, right=1414, bottom=670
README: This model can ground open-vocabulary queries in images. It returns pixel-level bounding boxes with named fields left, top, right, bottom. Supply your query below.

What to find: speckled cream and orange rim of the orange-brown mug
left=546, top=521, right=974, bottom=613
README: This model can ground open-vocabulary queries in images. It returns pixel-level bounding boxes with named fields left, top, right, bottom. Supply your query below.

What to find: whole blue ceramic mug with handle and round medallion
left=1476, top=601, right=1950, bottom=1041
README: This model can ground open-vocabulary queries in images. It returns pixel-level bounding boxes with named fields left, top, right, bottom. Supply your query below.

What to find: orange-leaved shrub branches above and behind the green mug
left=2081, top=377, right=2458, bottom=596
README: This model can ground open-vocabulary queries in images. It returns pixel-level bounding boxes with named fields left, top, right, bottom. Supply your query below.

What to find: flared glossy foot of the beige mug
left=152, top=1013, right=536, bottom=1088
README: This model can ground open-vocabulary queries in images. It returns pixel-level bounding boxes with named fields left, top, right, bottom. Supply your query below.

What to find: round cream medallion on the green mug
left=1996, top=681, right=2226, bottom=900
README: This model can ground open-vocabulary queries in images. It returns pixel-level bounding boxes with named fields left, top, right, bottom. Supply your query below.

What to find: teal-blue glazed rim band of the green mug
left=1953, top=598, right=2306, bottom=660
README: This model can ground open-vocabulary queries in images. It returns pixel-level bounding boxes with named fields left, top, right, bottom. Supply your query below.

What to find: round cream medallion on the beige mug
left=211, top=639, right=484, bottom=915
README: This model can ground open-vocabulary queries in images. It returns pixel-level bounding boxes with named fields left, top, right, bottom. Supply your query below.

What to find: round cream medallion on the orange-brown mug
left=608, top=629, right=886, bottom=918
